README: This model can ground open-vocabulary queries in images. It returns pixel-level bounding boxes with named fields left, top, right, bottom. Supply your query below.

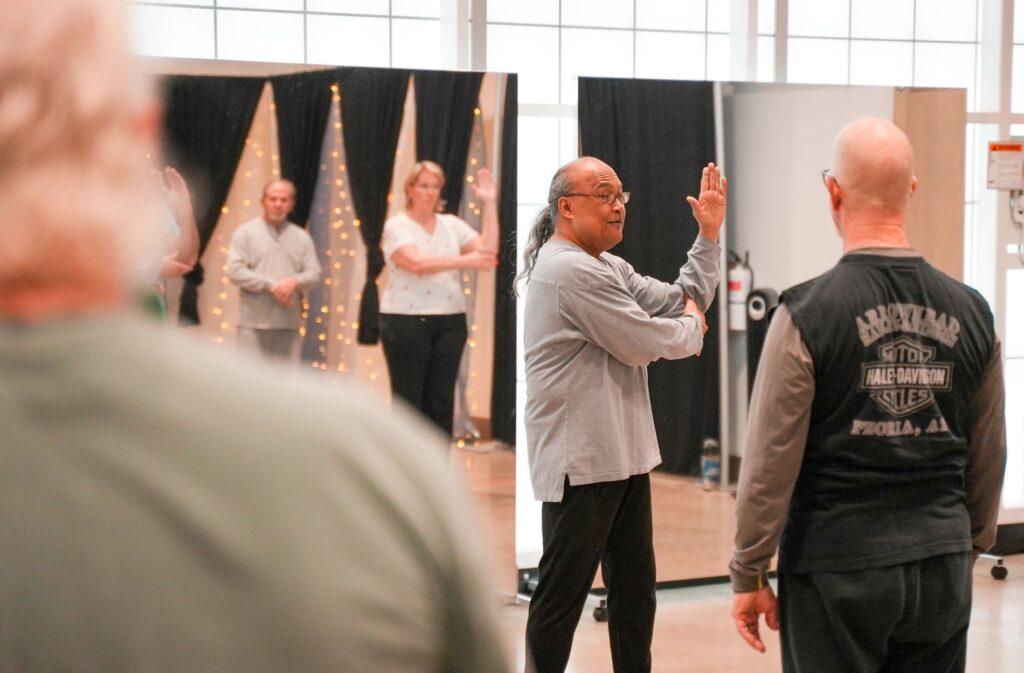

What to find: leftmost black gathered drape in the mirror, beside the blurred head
left=161, top=76, right=264, bottom=325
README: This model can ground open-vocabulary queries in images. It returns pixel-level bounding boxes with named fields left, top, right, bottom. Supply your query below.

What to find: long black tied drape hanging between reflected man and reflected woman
left=338, top=68, right=409, bottom=344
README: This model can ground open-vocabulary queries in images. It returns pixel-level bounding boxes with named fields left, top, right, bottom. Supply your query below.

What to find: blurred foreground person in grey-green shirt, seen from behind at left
left=0, top=0, right=506, bottom=673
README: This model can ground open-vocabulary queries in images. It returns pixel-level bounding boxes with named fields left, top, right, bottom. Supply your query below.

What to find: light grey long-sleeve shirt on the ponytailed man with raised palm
left=523, top=237, right=720, bottom=502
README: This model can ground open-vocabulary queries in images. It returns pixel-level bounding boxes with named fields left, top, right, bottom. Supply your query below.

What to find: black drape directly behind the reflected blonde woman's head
left=411, top=71, right=483, bottom=208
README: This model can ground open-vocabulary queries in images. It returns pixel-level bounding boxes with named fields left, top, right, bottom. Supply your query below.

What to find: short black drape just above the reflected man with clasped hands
left=270, top=70, right=338, bottom=226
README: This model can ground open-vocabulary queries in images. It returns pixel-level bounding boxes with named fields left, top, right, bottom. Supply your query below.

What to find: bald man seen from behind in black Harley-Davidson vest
left=729, top=118, right=1006, bottom=673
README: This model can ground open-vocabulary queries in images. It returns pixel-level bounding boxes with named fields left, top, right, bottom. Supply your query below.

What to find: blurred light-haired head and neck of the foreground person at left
left=0, top=0, right=159, bottom=293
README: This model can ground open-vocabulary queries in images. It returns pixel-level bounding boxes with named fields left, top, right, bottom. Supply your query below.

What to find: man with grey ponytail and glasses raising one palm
left=522, top=157, right=726, bottom=673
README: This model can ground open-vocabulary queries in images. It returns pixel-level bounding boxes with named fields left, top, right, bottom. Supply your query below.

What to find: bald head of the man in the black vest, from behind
left=831, top=117, right=915, bottom=213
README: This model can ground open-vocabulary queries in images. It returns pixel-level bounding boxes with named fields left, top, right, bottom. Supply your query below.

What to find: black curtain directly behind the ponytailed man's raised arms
left=579, top=77, right=724, bottom=474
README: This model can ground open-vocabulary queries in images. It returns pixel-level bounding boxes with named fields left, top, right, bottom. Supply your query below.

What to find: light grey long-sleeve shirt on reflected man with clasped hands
left=227, top=217, right=321, bottom=330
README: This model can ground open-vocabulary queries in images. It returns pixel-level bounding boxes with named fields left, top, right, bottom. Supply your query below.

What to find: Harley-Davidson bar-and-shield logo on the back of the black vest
left=859, top=336, right=953, bottom=417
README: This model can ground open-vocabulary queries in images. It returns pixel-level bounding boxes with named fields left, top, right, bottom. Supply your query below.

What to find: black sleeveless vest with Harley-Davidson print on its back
left=779, top=254, right=994, bottom=573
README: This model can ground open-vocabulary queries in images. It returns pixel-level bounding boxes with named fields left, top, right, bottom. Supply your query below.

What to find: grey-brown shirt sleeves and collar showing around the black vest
left=729, top=249, right=1006, bottom=592
